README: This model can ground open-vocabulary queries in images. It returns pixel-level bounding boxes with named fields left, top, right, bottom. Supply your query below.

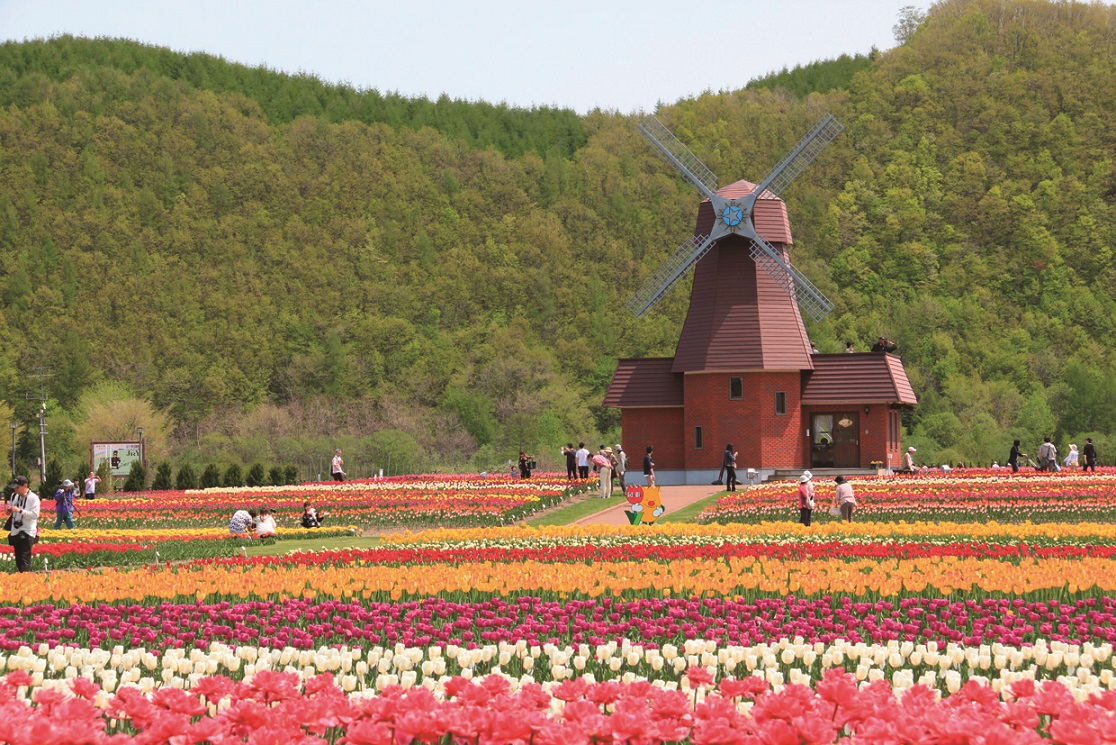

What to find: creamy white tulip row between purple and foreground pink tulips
left=0, top=638, right=1116, bottom=704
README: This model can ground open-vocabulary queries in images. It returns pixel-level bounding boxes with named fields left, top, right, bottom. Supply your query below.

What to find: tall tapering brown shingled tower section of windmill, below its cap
left=672, top=233, right=812, bottom=373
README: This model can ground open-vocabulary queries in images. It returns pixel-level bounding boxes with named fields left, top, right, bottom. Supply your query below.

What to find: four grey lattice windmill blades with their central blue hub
left=626, top=114, right=845, bottom=320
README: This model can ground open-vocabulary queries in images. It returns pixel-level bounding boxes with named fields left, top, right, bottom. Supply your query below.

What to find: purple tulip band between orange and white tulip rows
left=0, top=596, right=1116, bottom=650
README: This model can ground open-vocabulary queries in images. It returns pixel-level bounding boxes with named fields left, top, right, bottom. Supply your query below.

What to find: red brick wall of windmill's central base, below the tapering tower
left=678, top=371, right=804, bottom=470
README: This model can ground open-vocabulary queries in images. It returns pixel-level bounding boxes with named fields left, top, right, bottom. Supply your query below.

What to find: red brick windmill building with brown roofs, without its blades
left=604, top=181, right=917, bottom=484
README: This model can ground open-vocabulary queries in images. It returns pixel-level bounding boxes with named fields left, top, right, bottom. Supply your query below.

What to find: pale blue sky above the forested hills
left=0, top=0, right=929, bottom=113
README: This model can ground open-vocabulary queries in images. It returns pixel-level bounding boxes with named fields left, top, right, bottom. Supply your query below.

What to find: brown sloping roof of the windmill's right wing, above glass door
left=802, top=351, right=918, bottom=406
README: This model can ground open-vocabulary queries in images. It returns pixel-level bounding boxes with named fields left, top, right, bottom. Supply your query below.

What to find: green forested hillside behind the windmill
left=0, top=0, right=1116, bottom=470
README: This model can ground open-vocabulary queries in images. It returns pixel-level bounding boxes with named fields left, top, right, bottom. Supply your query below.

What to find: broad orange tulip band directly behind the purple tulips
left=10, top=557, right=1116, bottom=606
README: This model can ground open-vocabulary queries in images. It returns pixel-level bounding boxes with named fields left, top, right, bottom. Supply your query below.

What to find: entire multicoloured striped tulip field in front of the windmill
left=10, top=472, right=1116, bottom=745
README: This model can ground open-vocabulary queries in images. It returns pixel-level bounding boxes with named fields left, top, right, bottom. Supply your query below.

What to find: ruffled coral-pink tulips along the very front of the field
left=0, top=668, right=1116, bottom=745
